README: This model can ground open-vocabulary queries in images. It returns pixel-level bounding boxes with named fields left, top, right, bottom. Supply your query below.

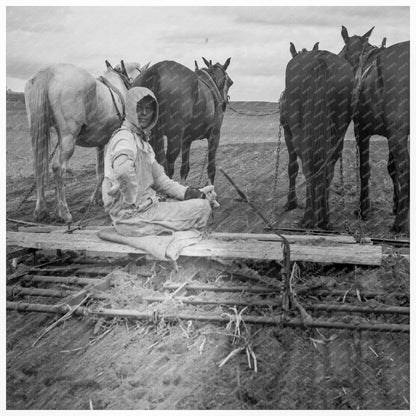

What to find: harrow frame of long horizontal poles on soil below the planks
left=6, top=244, right=409, bottom=332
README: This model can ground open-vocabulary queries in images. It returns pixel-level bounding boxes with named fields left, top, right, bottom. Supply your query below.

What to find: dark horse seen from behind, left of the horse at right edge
left=280, top=45, right=354, bottom=228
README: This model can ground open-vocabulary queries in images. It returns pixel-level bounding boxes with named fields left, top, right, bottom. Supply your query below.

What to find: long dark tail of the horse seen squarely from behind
left=302, top=58, right=333, bottom=227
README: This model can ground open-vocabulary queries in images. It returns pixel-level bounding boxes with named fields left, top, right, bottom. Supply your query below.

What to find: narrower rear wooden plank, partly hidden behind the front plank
left=18, top=225, right=357, bottom=245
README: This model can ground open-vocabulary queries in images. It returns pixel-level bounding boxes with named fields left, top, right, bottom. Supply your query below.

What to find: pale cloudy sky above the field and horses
left=6, top=2, right=410, bottom=101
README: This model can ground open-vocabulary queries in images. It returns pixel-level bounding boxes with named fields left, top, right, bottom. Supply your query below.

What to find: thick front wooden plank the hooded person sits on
left=6, top=231, right=382, bottom=265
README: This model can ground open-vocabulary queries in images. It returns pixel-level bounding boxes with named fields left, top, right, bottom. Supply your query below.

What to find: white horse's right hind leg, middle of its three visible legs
left=52, top=133, right=76, bottom=224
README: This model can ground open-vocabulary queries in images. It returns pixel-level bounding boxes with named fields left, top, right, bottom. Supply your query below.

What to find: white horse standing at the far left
left=25, top=61, right=140, bottom=223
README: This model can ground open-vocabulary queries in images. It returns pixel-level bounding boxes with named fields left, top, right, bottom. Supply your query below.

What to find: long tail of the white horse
left=25, top=69, right=53, bottom=181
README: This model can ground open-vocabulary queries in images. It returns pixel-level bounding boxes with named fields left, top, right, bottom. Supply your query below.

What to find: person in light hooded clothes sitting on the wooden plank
left=102, top=87, right=216, bottom=237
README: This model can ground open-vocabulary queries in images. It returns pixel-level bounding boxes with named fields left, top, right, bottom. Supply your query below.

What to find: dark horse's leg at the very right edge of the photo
left=388, top=131, right=410, bottom=233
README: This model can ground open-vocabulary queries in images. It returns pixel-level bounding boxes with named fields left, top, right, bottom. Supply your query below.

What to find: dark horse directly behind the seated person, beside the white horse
left=133, top=58, right=233, bottom=183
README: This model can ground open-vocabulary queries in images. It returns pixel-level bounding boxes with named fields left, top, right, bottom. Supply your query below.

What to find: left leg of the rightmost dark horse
left=355, top=129, right=371, bottom=220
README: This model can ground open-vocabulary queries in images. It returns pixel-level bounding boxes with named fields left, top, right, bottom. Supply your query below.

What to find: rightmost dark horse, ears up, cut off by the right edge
left=340, top=26, right=410, bottom=232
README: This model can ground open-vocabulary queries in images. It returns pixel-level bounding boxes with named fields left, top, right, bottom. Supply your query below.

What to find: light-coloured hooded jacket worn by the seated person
left=102, top=87, right=186, bottom=221
